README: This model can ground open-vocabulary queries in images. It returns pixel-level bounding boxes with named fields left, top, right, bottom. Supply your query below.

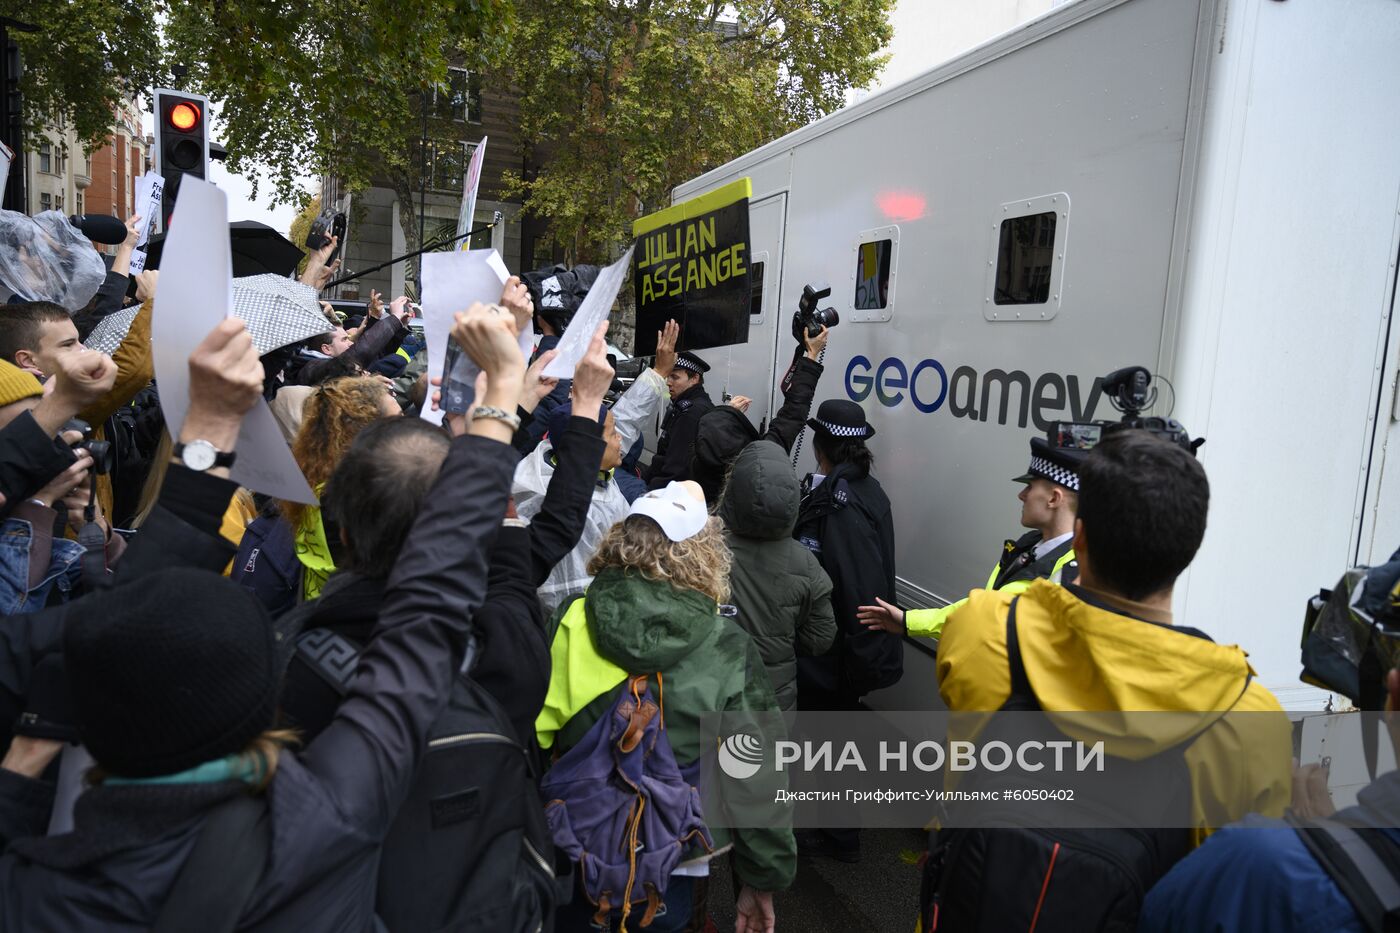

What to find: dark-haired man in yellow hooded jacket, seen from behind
left=925, top=430, right=1292, bottom=929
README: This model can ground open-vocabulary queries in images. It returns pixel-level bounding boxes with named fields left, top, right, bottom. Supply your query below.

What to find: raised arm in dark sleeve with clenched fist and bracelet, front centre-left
left=304, top=299, right=525, bottom=838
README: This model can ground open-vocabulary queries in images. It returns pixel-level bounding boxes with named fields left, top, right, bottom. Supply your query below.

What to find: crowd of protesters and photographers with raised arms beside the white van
left=0, top=196, right=1400, bottom=933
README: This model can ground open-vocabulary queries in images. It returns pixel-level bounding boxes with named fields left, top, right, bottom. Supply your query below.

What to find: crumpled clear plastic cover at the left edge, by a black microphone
left=0, top=210, right=106, bottom=311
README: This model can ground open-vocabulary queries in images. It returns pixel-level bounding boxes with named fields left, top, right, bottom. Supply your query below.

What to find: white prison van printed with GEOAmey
left=673, top=0, right=1400, bottom=710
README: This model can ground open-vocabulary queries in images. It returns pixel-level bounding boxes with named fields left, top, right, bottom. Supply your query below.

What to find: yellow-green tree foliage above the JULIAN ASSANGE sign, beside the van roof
left=501, top=0, right=895, bottom=259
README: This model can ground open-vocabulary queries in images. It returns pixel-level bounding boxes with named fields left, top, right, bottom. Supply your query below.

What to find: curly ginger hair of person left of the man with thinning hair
left=281, top=375, right=384, bottom=528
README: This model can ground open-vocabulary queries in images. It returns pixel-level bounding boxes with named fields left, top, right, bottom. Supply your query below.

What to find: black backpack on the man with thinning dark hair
left=297, top=629, right=571, bottom=933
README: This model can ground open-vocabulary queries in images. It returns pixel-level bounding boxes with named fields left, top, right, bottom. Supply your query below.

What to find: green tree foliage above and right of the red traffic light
left=164, top=0, right=511, bottom=291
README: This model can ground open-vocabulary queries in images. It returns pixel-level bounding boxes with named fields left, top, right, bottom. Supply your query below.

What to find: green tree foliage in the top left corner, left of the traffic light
left=0, top=0, right=162, bottom=151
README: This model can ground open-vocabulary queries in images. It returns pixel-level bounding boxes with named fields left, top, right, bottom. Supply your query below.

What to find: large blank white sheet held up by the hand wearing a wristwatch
left=151, top=177, right=318, bottom=504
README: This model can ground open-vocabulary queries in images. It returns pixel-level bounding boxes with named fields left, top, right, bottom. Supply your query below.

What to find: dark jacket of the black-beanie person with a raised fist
left=0, top=436, right=515, bottom=933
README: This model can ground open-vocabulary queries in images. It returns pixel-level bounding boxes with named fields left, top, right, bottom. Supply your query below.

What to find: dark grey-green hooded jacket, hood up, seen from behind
left=718, top=440, right=836, bottom=710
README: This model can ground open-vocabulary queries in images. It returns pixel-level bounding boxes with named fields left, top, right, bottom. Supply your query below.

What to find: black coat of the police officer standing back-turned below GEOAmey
left=792, top=465, right=904, bottom=703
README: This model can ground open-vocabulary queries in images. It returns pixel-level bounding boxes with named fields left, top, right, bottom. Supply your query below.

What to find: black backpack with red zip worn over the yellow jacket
left=920, top=597, right=1190, bottom=933
